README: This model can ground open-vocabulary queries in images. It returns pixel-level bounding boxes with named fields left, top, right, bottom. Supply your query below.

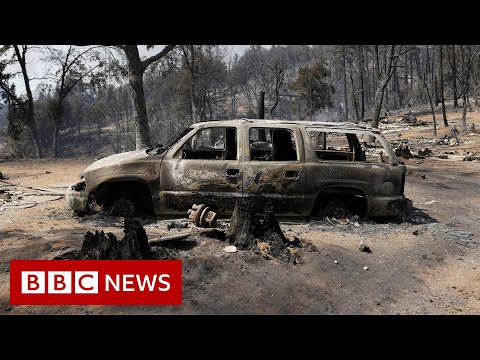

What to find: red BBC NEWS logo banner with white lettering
left=10, top=260, right=182, bottom=305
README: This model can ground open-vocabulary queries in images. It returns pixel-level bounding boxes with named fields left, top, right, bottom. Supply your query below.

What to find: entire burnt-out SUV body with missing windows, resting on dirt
left=66, top=119, right=407, bottom=217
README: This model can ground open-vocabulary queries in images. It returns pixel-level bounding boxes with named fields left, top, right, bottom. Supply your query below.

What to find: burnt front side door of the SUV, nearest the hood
left=160, top=126, right=243, bottom=214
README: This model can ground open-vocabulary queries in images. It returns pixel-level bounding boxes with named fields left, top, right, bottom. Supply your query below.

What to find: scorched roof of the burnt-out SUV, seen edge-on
left=192, top=118, right=380, bottom=133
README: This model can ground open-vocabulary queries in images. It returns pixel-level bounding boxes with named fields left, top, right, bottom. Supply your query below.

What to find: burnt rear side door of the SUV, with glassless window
left=243, top=123, right=305, bottom=216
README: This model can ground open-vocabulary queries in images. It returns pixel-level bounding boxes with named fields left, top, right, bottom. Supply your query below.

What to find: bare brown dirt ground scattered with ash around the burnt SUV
left=0, top=112, right=480, bottom=315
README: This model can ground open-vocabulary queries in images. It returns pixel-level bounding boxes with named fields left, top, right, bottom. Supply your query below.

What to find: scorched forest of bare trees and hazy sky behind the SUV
left=0, top=45, right=480, bottom=158
